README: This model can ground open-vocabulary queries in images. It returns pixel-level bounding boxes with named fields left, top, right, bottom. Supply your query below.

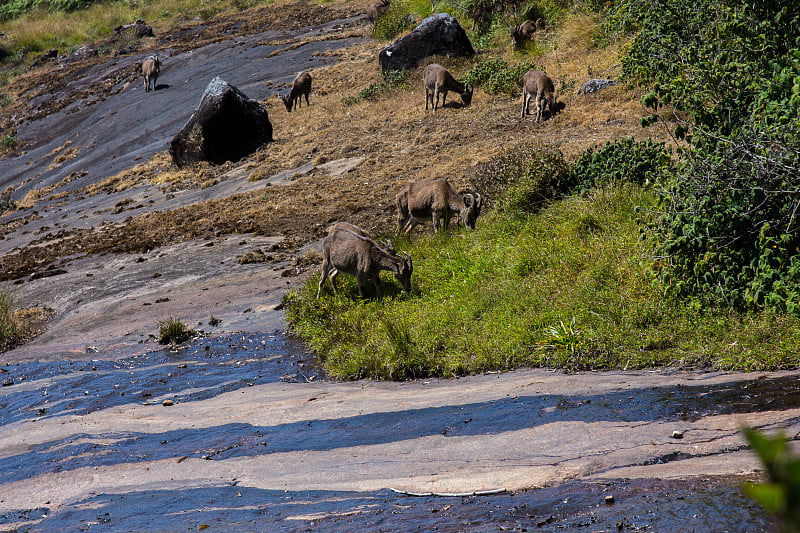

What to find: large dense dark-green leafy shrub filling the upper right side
left=610, top=0, right=800, bottom=315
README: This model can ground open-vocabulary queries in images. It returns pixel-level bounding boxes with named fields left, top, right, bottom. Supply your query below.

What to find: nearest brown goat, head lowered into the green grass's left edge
left=317, top=223, right=414, bottom=298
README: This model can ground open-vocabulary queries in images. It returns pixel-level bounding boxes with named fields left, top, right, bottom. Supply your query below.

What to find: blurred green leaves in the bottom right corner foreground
left=742, top=428, right=800, bottom=533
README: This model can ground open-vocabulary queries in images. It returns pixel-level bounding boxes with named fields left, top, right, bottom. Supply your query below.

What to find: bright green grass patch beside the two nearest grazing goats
left=288, top=183, right=800, bottom=380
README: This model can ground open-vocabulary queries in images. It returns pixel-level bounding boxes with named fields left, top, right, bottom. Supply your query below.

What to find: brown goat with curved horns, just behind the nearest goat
left=395, top=180, right=482, bottom=233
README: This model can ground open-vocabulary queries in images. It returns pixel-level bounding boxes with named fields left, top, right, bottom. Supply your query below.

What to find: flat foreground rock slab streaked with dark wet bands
left=0, top=360, right=800, bottom=531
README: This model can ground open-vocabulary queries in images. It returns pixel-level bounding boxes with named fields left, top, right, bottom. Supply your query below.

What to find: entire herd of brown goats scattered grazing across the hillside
left=142, top=4, right=555, bottom=298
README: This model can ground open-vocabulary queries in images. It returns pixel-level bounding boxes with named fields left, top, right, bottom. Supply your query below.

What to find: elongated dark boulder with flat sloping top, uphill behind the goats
left=378, top=13, right=475, bottom=73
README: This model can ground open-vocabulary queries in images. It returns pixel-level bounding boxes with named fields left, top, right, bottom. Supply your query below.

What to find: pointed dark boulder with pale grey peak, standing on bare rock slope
left=169, top=77, right=272, bottom=167
